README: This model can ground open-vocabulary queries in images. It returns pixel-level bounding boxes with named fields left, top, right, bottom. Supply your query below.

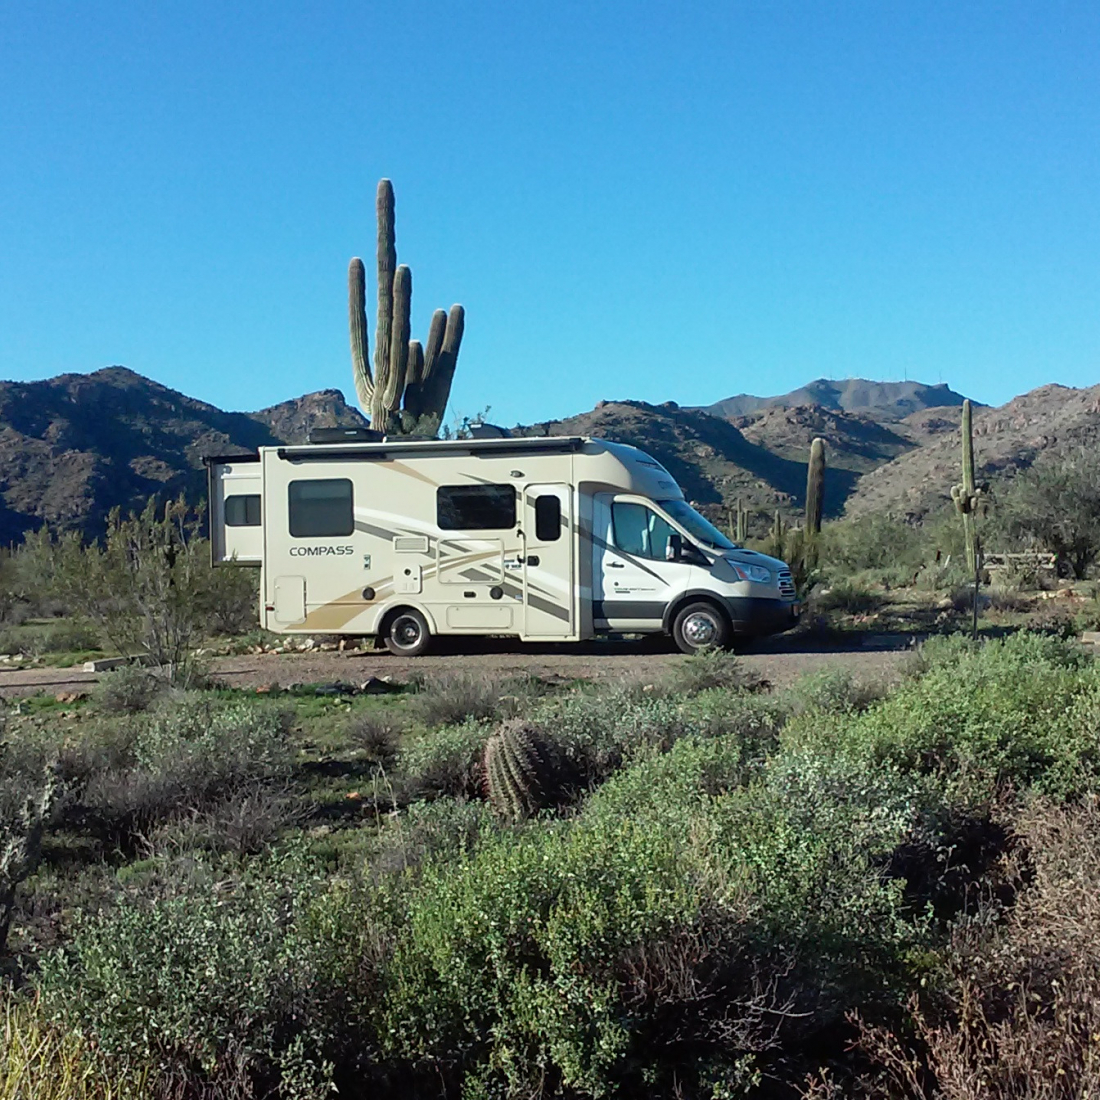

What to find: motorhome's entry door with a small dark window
left=523, top=484, right=576, bottom=639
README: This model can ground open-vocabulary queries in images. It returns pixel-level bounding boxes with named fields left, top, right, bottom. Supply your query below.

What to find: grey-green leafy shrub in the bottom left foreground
left=39, top=857, right=374, bottom=1100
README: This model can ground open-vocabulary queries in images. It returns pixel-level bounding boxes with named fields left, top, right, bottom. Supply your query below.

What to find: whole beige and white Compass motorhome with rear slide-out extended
left=207, top=437, right=800, bottom=656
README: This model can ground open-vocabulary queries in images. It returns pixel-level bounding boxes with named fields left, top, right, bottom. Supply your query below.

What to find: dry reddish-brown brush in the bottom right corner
left=860, top=799, right=1100, bottom=1100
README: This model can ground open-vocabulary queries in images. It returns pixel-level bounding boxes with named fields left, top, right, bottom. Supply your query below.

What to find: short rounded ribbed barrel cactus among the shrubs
left=482, top=718, right=568, bottom=821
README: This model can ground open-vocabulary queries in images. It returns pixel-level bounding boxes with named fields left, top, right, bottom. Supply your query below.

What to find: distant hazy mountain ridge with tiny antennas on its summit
left=705, top=378, right=963, bottom=422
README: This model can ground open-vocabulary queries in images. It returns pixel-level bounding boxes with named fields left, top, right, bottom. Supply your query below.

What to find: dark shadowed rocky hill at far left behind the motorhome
left=0, top=366, right=362, bottom=543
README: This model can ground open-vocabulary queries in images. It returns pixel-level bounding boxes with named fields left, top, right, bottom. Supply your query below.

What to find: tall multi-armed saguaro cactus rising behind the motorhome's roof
left=348, top=179, right=465, bottom=431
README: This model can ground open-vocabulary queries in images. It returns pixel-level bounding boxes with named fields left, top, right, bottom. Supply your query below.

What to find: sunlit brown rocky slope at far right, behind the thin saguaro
left=846, top=385, right=1100, bottom=518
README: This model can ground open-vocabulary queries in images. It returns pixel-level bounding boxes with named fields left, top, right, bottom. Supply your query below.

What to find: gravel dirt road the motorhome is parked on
left=0, top=636, right=910, bottom=699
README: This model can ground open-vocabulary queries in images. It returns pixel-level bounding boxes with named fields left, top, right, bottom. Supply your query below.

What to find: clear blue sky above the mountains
left=0, top=0, right=1100, bottom=424
